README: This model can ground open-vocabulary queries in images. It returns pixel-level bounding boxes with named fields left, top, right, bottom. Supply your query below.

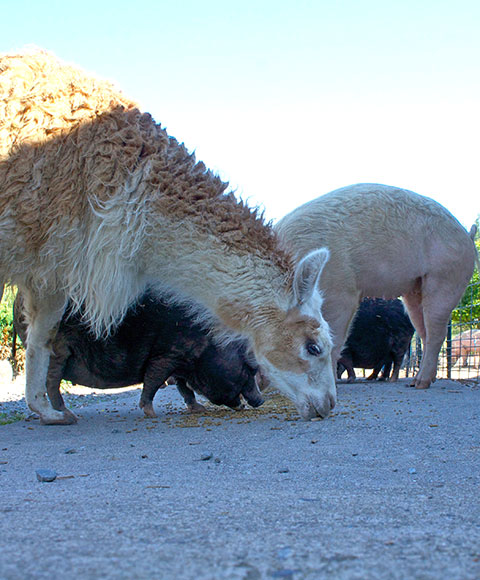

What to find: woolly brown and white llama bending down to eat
left=0, top=51, right=335, bottom=423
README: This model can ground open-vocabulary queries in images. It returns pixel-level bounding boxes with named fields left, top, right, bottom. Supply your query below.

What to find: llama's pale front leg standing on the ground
left=25, top=293, right=76, bottom=425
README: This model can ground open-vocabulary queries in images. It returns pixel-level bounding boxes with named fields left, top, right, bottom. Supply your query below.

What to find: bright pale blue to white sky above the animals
left=0, top=0, right=480, bottom=227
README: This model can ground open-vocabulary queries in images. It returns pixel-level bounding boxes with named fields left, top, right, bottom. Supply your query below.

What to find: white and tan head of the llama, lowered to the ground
left=219, top=248, right=336, bottom=419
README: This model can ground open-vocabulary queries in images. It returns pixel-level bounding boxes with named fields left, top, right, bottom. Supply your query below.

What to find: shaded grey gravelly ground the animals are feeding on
left=0, top=368, right=480, bottom=580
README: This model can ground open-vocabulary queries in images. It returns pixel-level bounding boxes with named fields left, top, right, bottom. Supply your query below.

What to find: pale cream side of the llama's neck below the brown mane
left=142, top=222, right=291, bottom=335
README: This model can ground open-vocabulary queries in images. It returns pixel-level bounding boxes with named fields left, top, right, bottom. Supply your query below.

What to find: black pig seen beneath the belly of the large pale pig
left=337, top=298, right=415, bottom=382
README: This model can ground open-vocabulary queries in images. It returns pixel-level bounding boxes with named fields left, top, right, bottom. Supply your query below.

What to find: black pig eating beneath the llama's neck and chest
left=14, top=292, right=263, bottom=421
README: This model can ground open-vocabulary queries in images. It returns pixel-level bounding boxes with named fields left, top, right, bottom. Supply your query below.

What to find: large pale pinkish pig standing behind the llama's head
left=275, top=183, right=478, bottom=389
